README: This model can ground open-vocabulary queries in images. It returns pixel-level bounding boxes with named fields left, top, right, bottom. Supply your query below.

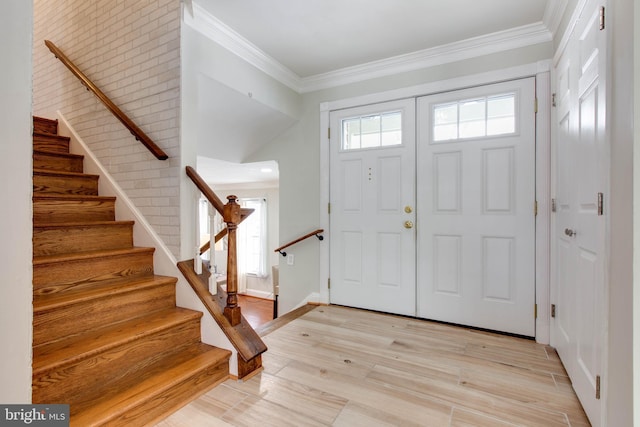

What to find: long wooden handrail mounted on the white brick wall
left=44, top=40, right=169, bottom=160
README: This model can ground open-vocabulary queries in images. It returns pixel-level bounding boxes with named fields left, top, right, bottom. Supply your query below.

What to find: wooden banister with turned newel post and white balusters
left=186, top=166, right=253, bottom=326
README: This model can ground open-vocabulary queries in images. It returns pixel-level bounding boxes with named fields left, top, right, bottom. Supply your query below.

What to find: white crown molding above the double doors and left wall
left=184, top=0, right=552, bottom=93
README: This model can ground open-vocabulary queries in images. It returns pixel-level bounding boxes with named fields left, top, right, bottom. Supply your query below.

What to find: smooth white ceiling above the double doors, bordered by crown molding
left=193, top=0, right=561, bottom=78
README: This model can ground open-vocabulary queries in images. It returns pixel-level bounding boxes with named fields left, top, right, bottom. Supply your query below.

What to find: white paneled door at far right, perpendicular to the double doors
left=551, top=1, right=609, bottom=426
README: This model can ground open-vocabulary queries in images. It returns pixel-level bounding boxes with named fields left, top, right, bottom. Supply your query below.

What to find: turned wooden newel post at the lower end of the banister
left=223, top=196, right=241, bottom=326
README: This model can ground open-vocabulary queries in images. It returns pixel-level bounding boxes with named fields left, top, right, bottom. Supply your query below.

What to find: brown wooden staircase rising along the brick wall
left=32, top=118, right=230, bottom=427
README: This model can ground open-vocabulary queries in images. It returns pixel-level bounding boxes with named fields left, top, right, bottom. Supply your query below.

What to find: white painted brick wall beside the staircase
left=33, top=0, right=180, bottom=256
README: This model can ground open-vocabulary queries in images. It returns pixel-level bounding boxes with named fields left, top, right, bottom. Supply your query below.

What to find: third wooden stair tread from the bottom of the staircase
left=33, top=275, right=178, bottom=314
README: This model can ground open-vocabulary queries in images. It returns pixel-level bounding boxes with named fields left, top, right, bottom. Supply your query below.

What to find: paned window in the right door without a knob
left=432, top=93, right=516, bottom=142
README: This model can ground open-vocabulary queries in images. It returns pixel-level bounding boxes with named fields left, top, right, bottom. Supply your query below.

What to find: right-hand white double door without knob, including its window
left=416, top=78, right=535, bottom=336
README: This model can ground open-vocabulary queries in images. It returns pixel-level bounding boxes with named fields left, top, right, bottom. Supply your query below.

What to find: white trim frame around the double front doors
left=318, top=60, right=551, bottom=344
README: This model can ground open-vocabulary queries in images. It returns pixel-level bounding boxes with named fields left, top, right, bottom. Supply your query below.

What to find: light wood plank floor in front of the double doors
left=152, top=306, right=589, bottom=427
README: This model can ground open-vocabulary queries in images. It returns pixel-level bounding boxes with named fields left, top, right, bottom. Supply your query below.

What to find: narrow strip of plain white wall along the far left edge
left=0, top=0, right=33, bottom=403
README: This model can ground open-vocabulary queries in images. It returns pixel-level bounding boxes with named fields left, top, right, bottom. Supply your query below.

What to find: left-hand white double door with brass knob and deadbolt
left=330, top=99, right=416, bottom=315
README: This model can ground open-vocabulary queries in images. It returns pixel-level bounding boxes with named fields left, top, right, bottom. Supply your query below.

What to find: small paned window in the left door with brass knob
left=342, top=111, right=402, bottom=150
